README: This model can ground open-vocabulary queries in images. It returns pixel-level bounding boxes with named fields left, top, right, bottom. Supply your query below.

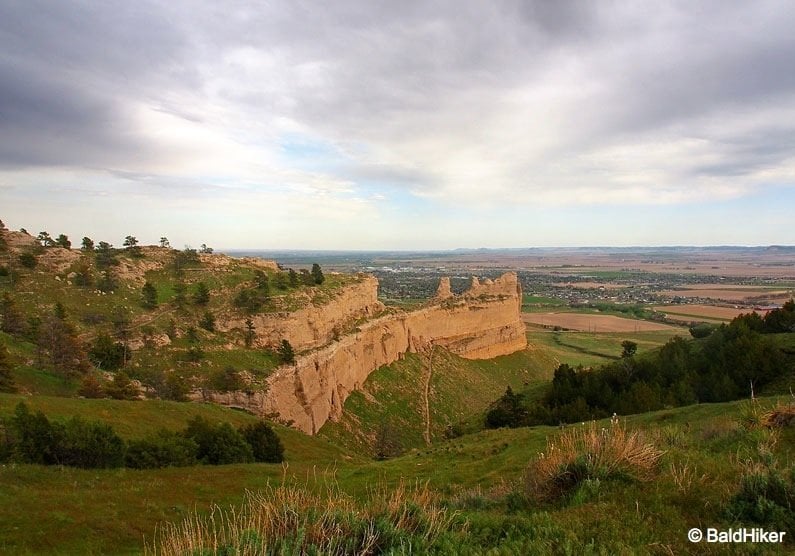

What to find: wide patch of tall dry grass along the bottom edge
left=146, top=482, right=455, bottom=556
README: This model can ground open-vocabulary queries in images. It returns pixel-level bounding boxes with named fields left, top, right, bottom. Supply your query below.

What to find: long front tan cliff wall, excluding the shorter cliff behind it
left=212, top=273, right=527, bottom=434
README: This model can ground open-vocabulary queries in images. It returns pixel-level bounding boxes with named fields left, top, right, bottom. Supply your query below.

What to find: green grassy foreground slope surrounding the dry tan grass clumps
left=0, top=397, right=795, bottom=554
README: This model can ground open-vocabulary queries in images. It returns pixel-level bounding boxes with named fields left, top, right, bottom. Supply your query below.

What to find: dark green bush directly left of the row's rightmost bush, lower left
left=184, top=416, right=254, bottom=465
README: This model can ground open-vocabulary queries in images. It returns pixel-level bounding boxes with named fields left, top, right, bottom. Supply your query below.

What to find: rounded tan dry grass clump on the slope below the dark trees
left=525, top=422, right=664, bottom=500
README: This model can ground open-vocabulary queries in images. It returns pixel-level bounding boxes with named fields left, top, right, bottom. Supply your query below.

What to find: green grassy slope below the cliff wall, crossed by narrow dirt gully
left=319, top=327, right=684, bottom=454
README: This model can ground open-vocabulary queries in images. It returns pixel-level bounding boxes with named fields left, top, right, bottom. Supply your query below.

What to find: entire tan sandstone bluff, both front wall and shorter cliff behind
left=207, top=273, right=527, bottom=434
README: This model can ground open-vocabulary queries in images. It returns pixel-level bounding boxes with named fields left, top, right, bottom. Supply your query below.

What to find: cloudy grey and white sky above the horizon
left=0, top=0, right=795, bottom=249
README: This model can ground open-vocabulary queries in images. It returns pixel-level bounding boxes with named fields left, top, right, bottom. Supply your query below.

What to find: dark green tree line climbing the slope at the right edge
left=486, top=301, right=795, bottom=428
